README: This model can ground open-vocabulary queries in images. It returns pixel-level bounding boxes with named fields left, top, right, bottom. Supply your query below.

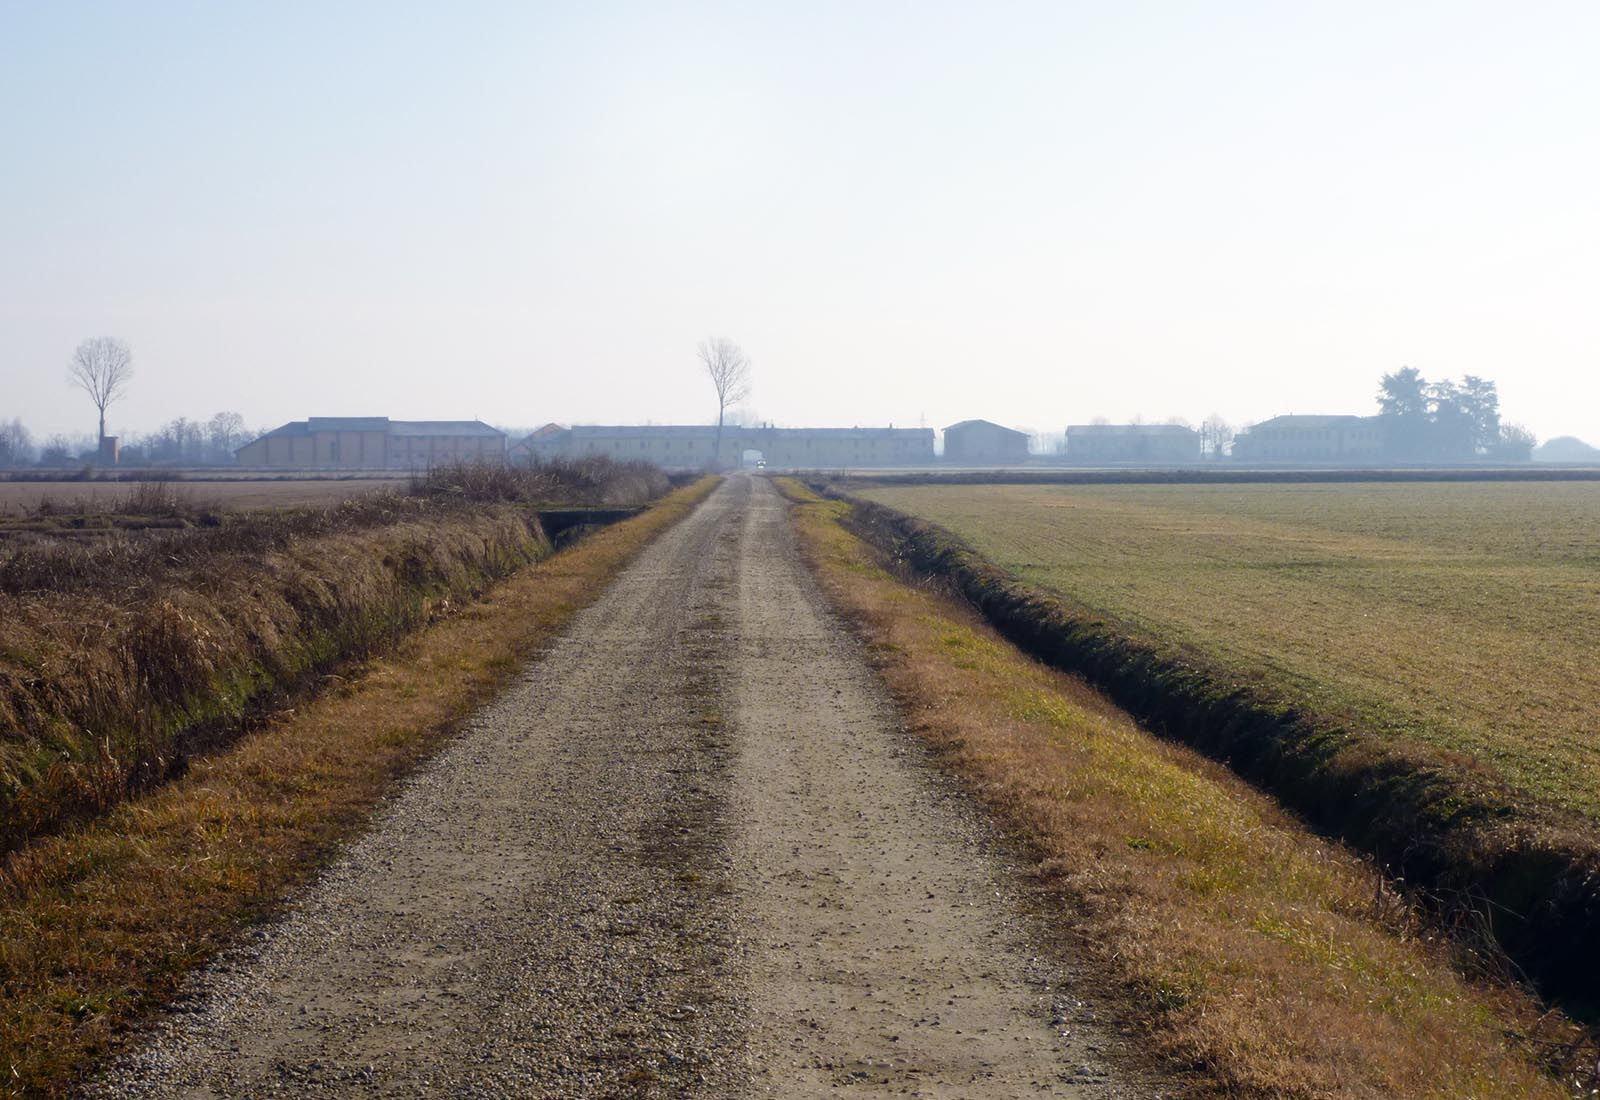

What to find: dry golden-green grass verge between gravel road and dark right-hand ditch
left=784, top=483, right=1578, bottom=1100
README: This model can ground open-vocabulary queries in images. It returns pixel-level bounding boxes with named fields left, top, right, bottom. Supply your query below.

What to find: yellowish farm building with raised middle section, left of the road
left=235, top=416, right=506, bottom=470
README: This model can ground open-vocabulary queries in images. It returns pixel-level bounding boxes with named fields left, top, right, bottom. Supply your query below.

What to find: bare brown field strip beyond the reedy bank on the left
left=0, top=478, right=410, bottom=516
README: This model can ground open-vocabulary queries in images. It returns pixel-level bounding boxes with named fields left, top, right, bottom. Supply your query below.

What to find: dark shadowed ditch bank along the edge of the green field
left=832, top=495, right=1600, bottom=1014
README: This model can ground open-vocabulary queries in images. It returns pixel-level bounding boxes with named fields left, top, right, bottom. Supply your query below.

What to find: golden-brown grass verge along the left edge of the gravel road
left=0, top=480, right=715, bottom=1097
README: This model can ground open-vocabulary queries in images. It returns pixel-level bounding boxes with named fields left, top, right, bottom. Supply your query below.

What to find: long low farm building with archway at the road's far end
left=510, top=424, right=933, bottom=470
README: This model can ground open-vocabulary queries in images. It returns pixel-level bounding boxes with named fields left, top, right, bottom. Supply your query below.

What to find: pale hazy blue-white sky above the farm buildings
left=0, top=0, right=1600, bottom=441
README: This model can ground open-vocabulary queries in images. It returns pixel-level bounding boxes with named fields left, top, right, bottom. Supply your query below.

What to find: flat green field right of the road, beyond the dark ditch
left=861, top=483, right=1600, bottom=819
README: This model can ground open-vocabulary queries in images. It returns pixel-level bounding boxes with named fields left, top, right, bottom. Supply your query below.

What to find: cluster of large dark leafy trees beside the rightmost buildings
left=1378, top=366, right=1534, bottom=462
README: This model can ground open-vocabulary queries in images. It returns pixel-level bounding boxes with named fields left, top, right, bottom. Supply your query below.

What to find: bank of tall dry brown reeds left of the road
left=0, top=497, right=637, bottom=852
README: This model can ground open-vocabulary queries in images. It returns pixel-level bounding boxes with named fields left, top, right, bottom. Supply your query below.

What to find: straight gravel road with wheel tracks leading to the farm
left=90, top=476, right=1158, bottom=1100
